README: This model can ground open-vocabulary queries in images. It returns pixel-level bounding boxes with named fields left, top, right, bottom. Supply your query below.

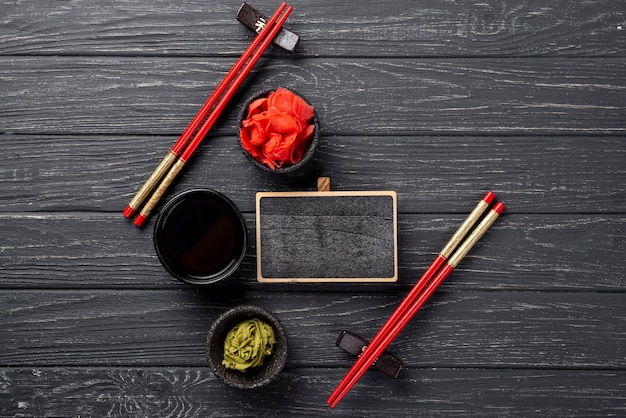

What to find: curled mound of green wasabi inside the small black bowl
left=222, top=318, right=276, bottom=371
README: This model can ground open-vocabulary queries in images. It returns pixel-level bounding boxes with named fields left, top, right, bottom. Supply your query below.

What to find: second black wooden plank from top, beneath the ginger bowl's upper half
left=0, top=57, right=626, bottom=135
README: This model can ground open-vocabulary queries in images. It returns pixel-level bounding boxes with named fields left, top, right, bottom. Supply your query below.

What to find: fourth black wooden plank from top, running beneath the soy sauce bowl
left=0, top=212, right=626, bottom=292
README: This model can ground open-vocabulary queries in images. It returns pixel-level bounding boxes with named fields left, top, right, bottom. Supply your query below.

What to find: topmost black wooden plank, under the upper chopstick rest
left=0, top=0, right=626, bottom=57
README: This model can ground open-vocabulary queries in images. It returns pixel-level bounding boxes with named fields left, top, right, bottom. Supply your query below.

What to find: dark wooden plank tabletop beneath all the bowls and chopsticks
left=0, top=0, right=626, bottom=417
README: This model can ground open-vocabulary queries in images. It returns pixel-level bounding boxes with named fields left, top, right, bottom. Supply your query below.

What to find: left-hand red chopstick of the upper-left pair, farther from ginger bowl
left=122, top=3, right=286, bottom=222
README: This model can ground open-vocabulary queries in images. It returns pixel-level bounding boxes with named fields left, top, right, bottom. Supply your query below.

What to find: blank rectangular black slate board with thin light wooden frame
left=256, top=191, right=398, bottom=282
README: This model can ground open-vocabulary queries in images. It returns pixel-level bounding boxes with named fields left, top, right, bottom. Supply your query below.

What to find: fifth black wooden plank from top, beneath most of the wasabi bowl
left=0, top=290, right=626, bottom=370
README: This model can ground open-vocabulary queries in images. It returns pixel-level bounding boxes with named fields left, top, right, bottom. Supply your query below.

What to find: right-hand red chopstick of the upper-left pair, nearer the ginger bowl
left=135, top=5, right=293, bottom=227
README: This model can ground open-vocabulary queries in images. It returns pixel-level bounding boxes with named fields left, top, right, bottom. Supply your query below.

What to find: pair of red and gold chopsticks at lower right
left=326, top=192, right=505, bottom=408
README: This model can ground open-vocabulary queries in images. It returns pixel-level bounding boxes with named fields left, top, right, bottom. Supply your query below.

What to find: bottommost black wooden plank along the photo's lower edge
left=0, top=367, right=626, bottom=418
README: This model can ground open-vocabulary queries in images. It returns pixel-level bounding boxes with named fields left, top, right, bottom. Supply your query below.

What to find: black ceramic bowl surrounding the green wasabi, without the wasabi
left=206, top=305, right=287, bottom=389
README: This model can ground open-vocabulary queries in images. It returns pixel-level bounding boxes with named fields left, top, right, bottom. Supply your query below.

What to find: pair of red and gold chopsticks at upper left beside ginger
left=123, top=3, right=293, bottom=226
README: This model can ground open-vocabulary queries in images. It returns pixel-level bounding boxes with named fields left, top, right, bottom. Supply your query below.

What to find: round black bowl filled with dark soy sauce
left=154, top=189, right=248, bottom=284
